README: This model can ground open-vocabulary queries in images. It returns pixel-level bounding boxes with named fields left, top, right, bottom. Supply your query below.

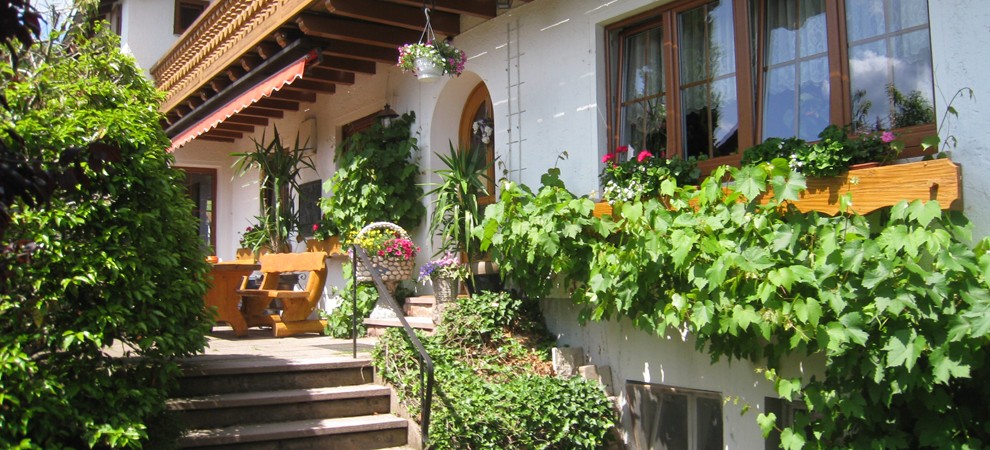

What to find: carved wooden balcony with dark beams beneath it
left=151, top=0, right=528, bottom=150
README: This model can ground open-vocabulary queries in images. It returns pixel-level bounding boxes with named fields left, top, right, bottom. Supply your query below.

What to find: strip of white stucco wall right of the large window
left=928, top=0, right=990, bottom=239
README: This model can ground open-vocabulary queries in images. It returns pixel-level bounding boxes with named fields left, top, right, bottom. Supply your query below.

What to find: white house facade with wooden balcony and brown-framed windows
left=103, top=0, right=990, bottom=449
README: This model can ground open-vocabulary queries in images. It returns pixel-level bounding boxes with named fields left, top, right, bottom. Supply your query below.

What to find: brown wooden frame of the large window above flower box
left=603, top=0, right=937, bottom=178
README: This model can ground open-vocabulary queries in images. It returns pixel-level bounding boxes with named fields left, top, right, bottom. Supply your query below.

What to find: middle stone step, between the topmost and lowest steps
left=168, top=384, right=391, bottom=428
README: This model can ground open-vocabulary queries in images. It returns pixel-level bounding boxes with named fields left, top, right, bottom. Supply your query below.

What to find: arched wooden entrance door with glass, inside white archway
left=458, top=83, right=495, bottom=206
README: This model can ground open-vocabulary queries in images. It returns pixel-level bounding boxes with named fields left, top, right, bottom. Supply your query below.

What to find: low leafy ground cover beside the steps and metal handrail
left=373, top=292, right=615, bottom=449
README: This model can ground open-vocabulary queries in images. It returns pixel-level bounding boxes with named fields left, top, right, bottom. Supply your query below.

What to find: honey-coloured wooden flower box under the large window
left=594, top=159, right=963, bottom=217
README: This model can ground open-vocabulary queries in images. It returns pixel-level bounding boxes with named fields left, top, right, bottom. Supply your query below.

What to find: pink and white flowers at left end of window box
left=600, top=145, right=701, bottom=203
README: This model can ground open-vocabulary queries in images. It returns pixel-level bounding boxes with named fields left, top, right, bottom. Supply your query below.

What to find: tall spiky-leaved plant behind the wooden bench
left=232, top=127, right=316, bottom=253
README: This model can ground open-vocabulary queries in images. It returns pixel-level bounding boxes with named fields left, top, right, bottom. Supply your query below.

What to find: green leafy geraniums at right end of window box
left=742, top=125, right=904, bottom=177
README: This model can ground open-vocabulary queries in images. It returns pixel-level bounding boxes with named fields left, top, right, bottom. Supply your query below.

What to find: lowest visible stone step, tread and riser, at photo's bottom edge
left=179, top=414, right=408, bottom=450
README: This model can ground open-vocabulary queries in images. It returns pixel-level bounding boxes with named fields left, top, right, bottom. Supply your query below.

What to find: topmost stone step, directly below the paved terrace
left=172, top=357, right=374, bottom=398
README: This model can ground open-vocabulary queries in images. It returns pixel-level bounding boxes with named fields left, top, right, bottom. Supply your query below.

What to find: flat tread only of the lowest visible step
left=179, top=414, right=409, bottom=447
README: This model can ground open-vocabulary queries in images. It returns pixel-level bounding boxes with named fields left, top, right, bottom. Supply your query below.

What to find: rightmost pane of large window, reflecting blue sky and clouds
left=846, top=0, right=935, bottom=129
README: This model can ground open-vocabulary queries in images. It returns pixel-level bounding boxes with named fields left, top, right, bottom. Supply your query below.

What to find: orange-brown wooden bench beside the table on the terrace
left=237, top=252, right=327, bottom=337
